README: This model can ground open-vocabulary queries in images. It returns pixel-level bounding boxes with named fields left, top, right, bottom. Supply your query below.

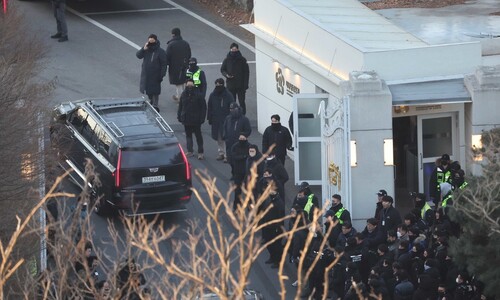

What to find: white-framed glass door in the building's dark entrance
left=417, top=113, right=456, bottom=195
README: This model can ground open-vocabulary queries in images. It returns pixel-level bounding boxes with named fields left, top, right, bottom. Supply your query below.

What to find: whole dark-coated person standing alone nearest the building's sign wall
left=220, top=43, right=250, bottom=115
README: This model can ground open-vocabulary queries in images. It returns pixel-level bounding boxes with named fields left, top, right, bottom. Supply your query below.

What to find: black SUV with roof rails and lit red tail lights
left=50, top=99, right=191, bottom=215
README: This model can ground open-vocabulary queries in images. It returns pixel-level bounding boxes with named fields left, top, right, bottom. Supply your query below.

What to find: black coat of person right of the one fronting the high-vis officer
left=207, top=88, right=234, bottom=140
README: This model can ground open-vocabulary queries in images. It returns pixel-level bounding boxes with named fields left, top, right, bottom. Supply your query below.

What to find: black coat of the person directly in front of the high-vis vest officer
left=177, top=89, right=207, bottom=125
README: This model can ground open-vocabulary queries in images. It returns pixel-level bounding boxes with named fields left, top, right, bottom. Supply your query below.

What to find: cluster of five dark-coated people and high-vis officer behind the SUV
left=136, top=28, right=251, bottom=163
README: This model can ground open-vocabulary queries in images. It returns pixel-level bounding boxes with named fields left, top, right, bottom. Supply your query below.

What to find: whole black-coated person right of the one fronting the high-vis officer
left=207, top=78, right=234, bottom=160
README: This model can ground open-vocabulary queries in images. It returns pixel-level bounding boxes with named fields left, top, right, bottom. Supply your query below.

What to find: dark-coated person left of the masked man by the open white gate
left=222, top=102, right=252, bottom=163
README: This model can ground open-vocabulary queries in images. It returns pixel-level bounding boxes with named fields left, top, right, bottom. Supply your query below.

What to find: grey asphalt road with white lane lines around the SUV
left=13, top=0, right=295, bottom=299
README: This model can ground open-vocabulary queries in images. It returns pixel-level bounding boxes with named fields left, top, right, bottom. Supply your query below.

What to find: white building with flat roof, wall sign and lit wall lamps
left=243, top=0, right=500, bottom=228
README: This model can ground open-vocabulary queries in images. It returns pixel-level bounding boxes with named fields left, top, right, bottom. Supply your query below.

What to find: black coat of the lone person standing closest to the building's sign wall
left=220, top=51, right=250, bottom=91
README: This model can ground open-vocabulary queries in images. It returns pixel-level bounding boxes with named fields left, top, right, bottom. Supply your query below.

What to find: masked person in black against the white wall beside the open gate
left=262, top=115, right=292, bottom=165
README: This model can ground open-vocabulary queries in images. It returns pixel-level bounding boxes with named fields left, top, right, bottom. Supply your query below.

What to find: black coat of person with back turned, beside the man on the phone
left=166, top=36, right=191, bottom=85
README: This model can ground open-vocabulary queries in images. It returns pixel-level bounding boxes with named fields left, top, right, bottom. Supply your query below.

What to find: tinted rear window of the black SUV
left=121, top=144, right=184, bottom=168
